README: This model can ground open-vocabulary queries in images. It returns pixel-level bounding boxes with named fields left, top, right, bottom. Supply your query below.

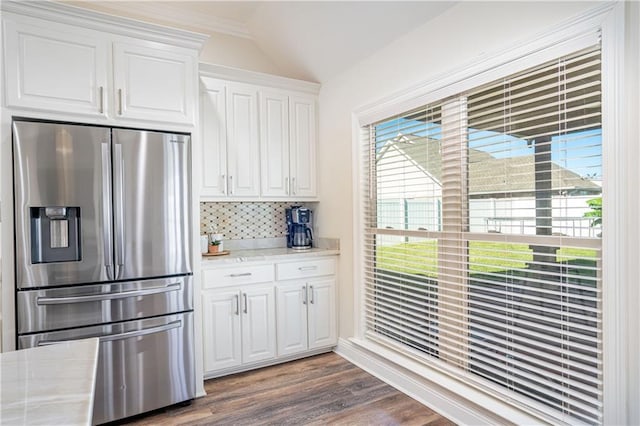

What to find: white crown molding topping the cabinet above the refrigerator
left=0, top=0, right=209, bottom=51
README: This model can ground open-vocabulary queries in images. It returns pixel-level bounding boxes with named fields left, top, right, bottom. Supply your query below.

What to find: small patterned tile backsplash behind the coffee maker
left=200, top=201, right=312, bottom=240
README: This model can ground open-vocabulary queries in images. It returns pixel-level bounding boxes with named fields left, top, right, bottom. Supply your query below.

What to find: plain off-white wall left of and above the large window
left=318, top=2, right=594, bottom=338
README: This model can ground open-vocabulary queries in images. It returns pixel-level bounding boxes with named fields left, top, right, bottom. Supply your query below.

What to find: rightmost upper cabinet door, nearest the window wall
left=289, top=96, right=317, bottom=197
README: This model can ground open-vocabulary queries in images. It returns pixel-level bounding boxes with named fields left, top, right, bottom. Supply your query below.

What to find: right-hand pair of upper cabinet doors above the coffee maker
left=260, top=90, right=317, bottom=199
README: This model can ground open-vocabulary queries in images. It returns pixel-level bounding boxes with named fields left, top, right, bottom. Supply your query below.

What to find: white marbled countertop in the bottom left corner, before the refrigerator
left=0, top=338, right=99, bottom=426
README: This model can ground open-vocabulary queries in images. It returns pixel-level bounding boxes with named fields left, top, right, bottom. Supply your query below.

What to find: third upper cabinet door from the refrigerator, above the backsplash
left=260, top=91, right=290, bottom=197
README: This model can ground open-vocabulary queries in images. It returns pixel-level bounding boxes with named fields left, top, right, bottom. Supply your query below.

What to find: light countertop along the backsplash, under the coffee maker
left=202, top=247, right=340, bottom=264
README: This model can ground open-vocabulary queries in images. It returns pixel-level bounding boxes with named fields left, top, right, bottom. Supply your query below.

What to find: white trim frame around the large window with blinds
left=352, top=3, right=633, bottom=424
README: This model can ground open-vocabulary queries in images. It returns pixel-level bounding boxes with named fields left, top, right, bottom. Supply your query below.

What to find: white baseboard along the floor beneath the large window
left=335, top=339, right=511, bottom=425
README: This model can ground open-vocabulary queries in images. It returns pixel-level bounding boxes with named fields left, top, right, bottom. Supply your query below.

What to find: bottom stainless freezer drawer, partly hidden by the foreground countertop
left=18, top=312, right=195, bottom=424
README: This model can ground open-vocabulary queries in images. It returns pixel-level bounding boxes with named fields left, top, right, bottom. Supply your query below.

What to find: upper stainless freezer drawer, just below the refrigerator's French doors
left=16, top=275, right=193, bottom=334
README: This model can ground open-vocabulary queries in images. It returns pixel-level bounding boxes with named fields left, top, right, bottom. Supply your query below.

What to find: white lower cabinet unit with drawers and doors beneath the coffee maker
left=202, top=256, right=337, bottom=377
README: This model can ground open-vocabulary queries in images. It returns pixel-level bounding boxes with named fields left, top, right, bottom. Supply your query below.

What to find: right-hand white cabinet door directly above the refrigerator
left=113, top=43, right=197, bottom=124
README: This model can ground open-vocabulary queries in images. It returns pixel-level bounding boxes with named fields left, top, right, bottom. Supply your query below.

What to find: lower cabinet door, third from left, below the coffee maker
left=276, top=282, right=307, bottom=356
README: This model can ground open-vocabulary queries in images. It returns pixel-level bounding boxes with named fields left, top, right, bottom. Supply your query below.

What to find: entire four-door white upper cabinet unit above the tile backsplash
left=200, top=64, right=318, bottom=201
